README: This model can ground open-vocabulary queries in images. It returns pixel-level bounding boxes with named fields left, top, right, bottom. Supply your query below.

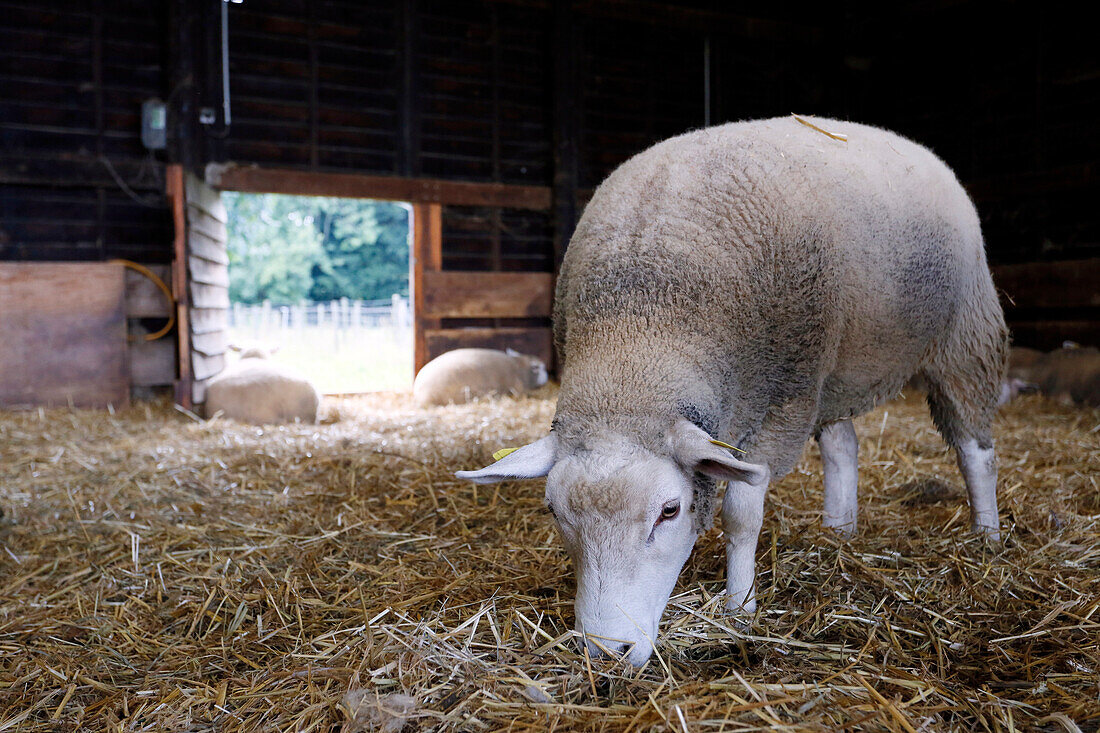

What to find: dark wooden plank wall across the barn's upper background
left=0, top=0, right=1100, bottom=347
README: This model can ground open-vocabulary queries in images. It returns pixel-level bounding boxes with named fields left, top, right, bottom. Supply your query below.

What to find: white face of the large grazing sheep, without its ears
left=546, top=442, right=699, bottom=666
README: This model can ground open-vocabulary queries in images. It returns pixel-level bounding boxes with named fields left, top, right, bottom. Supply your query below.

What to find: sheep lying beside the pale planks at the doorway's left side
left=206, top=347, right=321, bottom=425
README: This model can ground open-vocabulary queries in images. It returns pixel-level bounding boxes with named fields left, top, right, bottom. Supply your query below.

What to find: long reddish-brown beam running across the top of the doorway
left=206, top=163, right=550, bottom=211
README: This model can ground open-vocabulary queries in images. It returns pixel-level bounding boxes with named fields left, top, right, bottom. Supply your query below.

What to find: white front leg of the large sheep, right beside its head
left=722, top=468, right=770, bottom=614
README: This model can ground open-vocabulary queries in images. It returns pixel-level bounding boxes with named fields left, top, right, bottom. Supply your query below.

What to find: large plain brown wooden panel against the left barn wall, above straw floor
left=0, top=262, right=130, bottom=407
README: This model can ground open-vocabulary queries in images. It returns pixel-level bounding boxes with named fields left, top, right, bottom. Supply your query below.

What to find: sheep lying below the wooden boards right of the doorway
left=413, top=349, right=547, bottom=407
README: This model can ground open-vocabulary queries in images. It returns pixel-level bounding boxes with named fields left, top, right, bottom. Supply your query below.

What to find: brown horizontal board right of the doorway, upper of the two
left=420, top=272, right=553, bottom=318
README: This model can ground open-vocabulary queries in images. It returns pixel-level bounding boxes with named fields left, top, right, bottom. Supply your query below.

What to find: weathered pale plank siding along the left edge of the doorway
left=185, top=174, right=229, bottom=403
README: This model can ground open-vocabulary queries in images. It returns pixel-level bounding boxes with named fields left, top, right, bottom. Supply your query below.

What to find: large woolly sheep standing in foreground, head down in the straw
left=458, top=118, right=1008, bottom=665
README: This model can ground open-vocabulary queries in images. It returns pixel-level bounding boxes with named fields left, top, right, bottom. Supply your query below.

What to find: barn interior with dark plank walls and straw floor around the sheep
left=0, top=0, right=1100, bottom=733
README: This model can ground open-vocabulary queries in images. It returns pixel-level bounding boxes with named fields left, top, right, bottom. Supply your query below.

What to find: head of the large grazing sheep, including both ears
left=457, top=420, right=767, bottom=666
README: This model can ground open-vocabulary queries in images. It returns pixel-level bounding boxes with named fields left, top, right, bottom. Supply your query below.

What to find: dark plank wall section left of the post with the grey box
left=0, top=0, right=172, bottom=263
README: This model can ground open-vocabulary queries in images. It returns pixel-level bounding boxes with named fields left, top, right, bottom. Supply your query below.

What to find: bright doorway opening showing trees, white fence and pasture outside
left=222, top=192, right=413, bottom=394
